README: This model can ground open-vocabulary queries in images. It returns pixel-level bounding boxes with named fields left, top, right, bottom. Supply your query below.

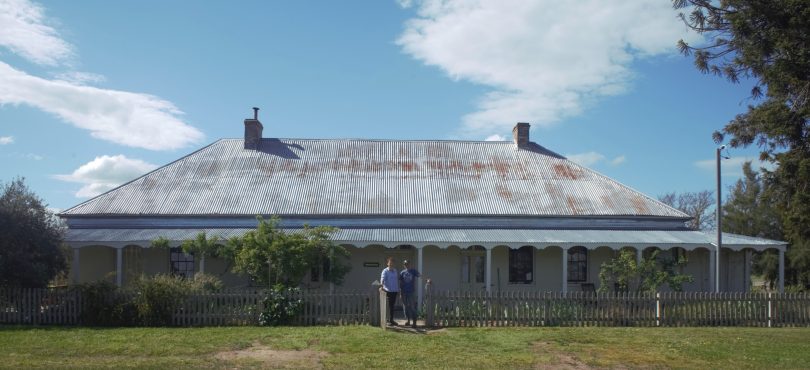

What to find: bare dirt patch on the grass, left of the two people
left=215, top=343, right=328, bottom=369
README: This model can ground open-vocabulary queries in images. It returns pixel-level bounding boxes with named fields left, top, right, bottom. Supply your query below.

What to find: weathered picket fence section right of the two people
left=424, top=289, right=810, bottom=327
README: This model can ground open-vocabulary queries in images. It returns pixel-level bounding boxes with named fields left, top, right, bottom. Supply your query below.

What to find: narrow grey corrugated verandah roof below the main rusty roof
left=65, top=229, right=787, bottom=249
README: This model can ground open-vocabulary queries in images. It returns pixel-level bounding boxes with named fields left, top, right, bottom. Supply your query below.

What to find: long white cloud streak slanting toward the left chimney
left=0, top=62, right=203, bottom=150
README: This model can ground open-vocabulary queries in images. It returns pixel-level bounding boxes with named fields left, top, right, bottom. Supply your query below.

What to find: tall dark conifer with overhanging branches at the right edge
left=673, top=0, right=810, bottom=287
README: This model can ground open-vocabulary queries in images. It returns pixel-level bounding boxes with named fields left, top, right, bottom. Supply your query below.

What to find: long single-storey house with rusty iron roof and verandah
left=60, top=110, right=786, bottom=304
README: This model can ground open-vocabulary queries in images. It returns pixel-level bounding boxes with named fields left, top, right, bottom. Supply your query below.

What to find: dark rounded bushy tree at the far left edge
left=0, top=178, right=67, bottom=288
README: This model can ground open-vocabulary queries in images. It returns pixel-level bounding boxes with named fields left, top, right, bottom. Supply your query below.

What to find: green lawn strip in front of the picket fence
left=0, top=326, right=810, bottom=369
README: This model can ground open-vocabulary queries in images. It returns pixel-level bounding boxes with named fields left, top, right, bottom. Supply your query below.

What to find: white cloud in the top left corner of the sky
left=0, top=0, right=73, bottom=66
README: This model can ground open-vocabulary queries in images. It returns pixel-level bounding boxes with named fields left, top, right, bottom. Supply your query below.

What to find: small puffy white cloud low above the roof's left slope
left=54, top=155, right=157, bottom=198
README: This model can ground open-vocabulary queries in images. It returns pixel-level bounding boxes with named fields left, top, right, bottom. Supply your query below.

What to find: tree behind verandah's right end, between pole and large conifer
left=723, top=162, right=784, bottom=287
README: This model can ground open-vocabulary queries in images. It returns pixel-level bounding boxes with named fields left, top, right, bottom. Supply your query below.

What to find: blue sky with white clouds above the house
left=0, top=0, right=757, bottom=209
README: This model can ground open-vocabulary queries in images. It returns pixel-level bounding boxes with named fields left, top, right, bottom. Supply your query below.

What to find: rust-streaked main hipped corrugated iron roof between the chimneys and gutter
left=62, top=138, right=688, bottom=218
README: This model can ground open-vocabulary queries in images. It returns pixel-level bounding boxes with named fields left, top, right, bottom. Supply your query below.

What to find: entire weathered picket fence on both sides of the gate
left=0, top=287, right=810, bottom=327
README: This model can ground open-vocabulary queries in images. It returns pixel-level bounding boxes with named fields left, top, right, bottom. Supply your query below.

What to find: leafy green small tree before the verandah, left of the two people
left=228, top=217, right=350, bottom=287
